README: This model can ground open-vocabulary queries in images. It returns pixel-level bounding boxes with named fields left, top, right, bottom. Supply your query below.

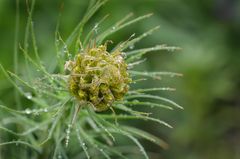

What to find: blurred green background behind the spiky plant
left=0, top=0, right=240, bottom=159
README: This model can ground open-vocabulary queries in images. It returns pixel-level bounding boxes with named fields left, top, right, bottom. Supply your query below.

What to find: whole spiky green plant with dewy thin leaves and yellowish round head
left=0, top=1, right=181, bottom=158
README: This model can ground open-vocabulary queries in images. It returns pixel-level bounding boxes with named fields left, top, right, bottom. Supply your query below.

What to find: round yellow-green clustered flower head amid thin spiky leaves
left=66, top=45, right=132, bottom=111
